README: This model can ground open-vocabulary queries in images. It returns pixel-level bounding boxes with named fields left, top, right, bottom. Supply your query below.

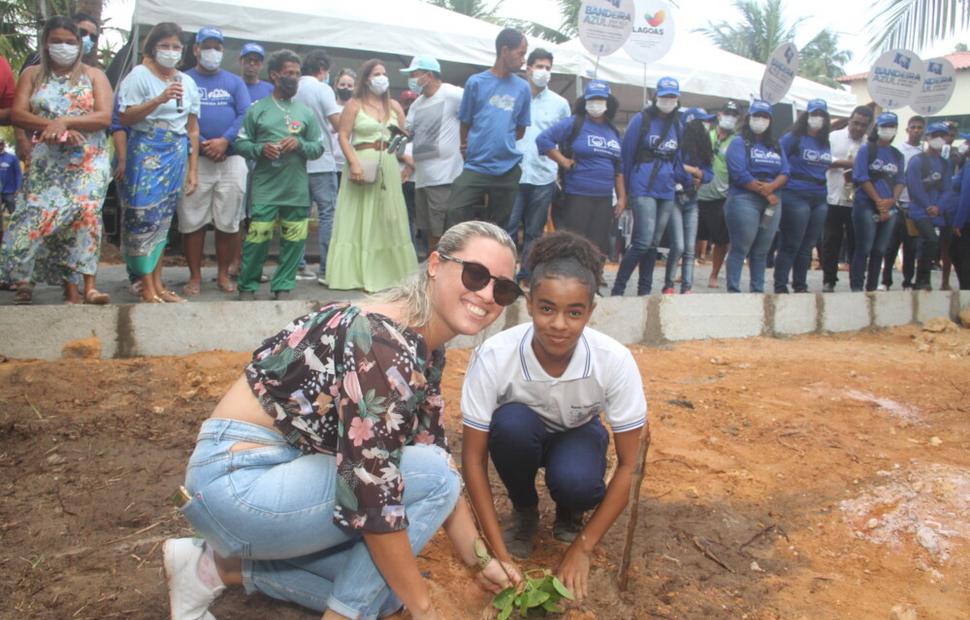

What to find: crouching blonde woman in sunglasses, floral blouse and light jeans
left=164, top=222, right=521, bottom=620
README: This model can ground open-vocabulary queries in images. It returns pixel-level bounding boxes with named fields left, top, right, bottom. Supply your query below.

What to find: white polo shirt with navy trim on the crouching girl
left=461, top=322, right=647, bottom=433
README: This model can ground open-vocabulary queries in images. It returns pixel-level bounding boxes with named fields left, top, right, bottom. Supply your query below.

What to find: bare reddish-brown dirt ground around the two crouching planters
left=0, top=325, right=970, bottom=620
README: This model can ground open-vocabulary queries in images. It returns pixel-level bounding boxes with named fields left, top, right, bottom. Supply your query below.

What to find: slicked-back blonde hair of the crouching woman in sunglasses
left=370, top=221, right=516, bottom=327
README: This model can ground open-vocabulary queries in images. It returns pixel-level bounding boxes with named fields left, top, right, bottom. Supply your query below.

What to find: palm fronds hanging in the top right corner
left=868, top=0, right=970, bottom=56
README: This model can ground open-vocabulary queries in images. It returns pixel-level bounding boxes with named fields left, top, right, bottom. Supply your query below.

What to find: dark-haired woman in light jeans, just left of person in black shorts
left=663, top=108, right=714, bottom=295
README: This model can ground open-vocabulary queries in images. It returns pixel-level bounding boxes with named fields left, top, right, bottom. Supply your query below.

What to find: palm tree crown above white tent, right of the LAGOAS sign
left=697, top=0, right=805, bottom=63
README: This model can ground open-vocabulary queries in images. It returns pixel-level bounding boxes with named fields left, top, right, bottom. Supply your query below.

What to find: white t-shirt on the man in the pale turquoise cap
left=407, top=84, right=465, bottom=188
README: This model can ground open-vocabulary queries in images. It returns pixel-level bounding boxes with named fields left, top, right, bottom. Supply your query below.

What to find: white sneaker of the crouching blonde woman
left=162, top=538, right=226, bottom=620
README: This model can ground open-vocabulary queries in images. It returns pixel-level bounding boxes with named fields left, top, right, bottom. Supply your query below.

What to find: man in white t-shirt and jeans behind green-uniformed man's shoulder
left=296, top=50, right=341, bottom=285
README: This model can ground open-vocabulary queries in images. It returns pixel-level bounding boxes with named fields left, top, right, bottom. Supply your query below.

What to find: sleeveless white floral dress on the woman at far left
left=0, top=73, right=111, bottom=285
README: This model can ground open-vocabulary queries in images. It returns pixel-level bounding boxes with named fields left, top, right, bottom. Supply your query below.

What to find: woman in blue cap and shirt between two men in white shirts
left=849, top=112, right=912, bottom=292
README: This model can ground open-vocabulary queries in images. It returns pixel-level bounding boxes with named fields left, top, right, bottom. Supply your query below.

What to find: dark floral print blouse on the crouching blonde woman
left=246, top=303, right=448, bottom=532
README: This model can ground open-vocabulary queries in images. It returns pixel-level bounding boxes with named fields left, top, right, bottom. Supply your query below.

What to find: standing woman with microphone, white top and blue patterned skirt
left=118, top=22, right=201, bottom=303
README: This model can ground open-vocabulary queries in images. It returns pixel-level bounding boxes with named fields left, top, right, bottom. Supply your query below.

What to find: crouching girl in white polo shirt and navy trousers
left=461, top=232, right=647, bottom=600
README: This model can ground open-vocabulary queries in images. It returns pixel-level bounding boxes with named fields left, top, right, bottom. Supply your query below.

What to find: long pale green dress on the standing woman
left=326, top=109, right=418, bottom=292
